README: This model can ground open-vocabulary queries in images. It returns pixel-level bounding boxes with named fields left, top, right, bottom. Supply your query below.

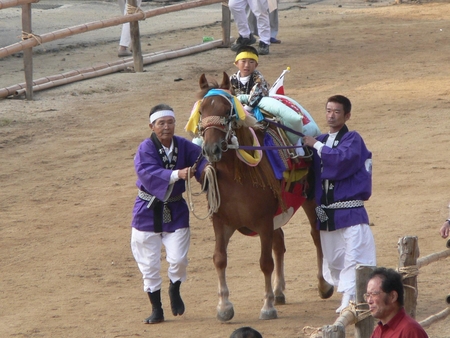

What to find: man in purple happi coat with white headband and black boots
left=131, top=104, right=207, bottom=324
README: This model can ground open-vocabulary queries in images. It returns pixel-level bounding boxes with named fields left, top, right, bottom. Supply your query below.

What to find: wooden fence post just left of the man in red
left=355, top=264, right=376, bottom=338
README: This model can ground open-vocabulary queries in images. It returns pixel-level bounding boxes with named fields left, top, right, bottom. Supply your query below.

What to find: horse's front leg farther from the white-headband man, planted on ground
left=259, top=227, right=278, bottom=319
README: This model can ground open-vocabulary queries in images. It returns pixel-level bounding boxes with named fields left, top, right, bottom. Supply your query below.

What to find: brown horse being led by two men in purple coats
left=195, top=73, right=333, bottom=321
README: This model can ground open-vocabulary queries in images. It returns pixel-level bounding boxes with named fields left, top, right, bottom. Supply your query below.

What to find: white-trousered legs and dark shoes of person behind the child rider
left=228, top=0, right=270, bottom=55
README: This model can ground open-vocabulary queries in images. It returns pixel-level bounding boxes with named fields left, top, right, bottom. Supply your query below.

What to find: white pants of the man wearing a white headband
left=131, top=228, right=190, bottom=292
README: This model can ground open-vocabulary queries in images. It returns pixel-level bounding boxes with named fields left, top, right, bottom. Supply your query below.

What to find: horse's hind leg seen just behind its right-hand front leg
left=272, top=228, right=286, bottom=305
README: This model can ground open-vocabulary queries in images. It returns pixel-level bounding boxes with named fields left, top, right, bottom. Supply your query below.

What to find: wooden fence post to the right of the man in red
left=398, top=236, right=419, bottom=318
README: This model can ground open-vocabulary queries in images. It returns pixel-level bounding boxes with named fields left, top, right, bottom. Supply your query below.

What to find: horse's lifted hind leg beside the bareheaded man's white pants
left=302, top=199, right=334, bottom=299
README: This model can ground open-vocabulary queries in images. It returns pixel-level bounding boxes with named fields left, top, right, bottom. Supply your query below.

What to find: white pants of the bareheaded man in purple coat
left=320, top=224, right=377, bottom=295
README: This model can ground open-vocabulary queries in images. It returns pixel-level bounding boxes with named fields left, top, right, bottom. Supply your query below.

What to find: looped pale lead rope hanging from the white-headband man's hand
left=186, top=164, right=220, bottom=220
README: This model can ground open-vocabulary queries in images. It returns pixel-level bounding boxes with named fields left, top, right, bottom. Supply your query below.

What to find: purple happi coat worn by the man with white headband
left=131, top=136, right=207, bottom=232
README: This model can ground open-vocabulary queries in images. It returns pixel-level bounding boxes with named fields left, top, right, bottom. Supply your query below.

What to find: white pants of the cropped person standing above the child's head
left=228, top=0, right=270, bottom=45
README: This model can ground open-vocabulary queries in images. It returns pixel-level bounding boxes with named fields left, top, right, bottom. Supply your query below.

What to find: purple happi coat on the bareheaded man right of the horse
left=314, top=126, right=372, bottom=231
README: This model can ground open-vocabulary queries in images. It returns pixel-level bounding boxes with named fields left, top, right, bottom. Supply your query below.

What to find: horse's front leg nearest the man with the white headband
left=213, top=217, right=234, bottom=322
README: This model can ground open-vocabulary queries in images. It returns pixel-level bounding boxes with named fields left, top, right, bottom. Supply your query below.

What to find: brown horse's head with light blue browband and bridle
left=199, top=72, right=236, bottom=162
